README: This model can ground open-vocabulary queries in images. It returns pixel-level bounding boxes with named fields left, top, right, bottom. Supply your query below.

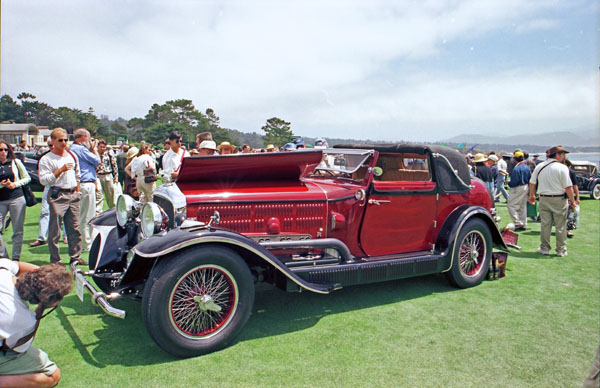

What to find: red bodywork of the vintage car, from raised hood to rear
left=172, top=150, right=492, bottom=257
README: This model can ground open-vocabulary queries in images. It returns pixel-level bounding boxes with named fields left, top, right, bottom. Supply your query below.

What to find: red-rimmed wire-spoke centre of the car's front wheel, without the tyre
left=170, top=265, right=239, bottom=339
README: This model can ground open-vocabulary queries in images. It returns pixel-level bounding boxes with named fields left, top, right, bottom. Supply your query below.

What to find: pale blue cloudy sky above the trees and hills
left=0, top=0, right=600, bottom=141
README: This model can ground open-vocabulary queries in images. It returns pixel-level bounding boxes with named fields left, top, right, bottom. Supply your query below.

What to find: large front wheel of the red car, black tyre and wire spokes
left=142, top=244, right=254, bottom=357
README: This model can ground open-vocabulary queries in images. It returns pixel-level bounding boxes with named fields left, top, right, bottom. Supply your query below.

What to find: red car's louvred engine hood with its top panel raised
left=177, top=150, right=356, bottom=230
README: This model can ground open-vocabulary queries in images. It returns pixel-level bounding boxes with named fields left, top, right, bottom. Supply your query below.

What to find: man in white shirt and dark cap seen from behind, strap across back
left=529, top=146, right=575, bottom=257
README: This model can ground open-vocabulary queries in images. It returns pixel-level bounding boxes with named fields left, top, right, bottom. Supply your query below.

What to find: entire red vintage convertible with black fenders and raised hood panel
left=73, top=144, right=507, bottom=357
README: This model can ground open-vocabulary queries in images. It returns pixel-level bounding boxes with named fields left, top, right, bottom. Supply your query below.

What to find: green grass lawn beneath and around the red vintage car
left=5, top=199, right=600, bottom=388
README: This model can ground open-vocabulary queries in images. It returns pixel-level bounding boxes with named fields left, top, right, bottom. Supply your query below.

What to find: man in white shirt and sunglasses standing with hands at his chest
left=38, top=128, right=87, bottom=265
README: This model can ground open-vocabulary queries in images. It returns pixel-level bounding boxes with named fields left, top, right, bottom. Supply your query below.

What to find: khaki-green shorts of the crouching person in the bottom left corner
left=0, top=346, right=57, bottom=376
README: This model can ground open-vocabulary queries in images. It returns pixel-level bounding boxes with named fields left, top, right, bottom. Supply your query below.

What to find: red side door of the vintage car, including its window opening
left=360, top=154, right=436, bottom=256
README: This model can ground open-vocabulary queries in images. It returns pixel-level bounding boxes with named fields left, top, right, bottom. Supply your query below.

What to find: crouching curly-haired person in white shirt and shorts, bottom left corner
left=0, top=259, right=73, bottom=388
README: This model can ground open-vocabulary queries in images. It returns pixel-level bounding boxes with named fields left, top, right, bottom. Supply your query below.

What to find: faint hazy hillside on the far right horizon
left=442, top=129, right=600, bottom=147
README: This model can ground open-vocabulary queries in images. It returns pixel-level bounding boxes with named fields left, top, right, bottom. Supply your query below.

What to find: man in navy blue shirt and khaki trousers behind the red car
left=506, top=151, right=531, bottom=231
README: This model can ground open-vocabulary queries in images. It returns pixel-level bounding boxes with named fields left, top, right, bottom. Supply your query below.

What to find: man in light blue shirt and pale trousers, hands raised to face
left=71, top=128, right=100, bottom=252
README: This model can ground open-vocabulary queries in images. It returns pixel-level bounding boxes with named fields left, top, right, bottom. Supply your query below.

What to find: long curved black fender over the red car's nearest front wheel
left=131, top=228, right=337, bottom=294
